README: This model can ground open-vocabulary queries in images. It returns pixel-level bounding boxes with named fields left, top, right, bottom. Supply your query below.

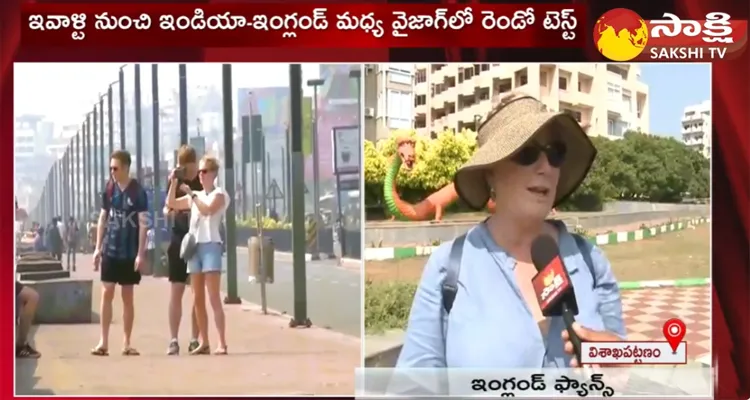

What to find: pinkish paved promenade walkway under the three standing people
left=16, top=256, right=361, bottom=396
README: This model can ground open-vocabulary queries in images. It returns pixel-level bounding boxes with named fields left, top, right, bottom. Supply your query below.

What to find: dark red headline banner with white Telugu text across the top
left=21, top=3, right=586, bottom=48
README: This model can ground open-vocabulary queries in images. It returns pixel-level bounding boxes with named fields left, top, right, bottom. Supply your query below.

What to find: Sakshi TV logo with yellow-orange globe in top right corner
left=593, top=8, right=747, bottom=62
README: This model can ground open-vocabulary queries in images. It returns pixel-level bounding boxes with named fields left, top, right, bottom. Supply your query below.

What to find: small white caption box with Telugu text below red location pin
left=581, top=342, right=687, bottom=365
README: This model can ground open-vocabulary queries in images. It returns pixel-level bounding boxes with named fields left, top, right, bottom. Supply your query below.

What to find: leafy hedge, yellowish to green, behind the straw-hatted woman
left=364, top=131, right=710, bottom=219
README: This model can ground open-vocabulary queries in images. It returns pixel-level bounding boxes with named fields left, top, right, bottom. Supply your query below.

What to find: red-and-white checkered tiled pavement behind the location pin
left=622, top=285, right=711, bottom=360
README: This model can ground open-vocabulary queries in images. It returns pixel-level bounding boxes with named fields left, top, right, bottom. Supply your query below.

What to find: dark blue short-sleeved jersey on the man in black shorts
left=102, top=180, right=148, bottom=260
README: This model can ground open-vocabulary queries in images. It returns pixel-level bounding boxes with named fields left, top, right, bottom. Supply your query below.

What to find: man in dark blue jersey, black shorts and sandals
left=91, top=150, right=148, bottom=356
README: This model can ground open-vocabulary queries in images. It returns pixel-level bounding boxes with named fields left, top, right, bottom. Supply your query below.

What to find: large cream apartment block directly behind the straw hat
left=413, top=63, right=649, bottom=139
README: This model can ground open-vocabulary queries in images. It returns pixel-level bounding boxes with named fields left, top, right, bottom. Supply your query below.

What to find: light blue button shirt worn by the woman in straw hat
left=397, top=222, right=625, bottom=369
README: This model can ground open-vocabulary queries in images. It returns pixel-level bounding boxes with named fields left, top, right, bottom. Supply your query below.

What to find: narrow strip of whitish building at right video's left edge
left=364, top=64, right=414, bottom=141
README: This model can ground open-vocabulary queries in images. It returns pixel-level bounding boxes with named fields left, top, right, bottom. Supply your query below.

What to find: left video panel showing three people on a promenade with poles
left=8, top=63, right=363, bottom=396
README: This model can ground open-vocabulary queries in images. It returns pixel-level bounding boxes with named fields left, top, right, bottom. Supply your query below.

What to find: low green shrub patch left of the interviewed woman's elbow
left=365, top=281, right=417, bottom=334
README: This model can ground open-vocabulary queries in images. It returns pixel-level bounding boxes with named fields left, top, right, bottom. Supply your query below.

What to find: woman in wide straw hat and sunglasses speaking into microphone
left=397, top=95, right=625, bottom=368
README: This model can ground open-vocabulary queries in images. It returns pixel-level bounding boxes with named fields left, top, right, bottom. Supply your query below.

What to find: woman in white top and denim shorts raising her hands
left=167, top=156, right=230, bottom=354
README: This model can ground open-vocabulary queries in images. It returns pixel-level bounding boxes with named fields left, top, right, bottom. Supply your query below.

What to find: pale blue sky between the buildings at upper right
left=641, top=63, right=711, bottom=139
